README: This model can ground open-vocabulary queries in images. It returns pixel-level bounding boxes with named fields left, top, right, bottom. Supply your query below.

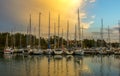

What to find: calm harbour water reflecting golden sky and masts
left=0, top=55, right=120, bottom=76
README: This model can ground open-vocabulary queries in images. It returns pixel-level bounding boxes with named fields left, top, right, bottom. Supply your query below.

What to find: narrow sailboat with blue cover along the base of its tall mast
left=45, top=12, right=53, bottom=55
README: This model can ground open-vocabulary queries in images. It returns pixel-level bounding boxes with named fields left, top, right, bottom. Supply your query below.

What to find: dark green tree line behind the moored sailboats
left=0, top=32, right=119, bottom=50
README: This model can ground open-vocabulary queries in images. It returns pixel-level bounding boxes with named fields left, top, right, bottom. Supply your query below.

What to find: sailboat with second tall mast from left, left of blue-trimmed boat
left=33, top=13, right=43, bottom=55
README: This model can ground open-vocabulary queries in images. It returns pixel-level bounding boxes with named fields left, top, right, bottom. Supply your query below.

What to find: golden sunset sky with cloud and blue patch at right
left=0, top=0, right=120, bottom=41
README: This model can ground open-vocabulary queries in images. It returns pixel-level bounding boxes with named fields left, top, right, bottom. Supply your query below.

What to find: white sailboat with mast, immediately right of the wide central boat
left=65, top=21, right=73, bottom=55
